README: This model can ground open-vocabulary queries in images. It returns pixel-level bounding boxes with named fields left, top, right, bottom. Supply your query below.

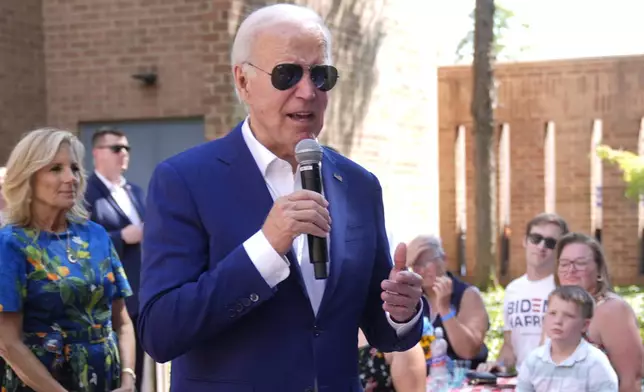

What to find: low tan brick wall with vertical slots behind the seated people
left=438, top=56, right=644, bottom=283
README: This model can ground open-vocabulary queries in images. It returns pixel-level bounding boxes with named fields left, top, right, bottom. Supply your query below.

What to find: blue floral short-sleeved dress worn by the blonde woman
left=0, top=221, right=132, bottom=392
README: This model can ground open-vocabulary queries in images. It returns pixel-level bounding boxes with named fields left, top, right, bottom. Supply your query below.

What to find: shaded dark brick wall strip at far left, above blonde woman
left=0, top=0, right=46, bottom=166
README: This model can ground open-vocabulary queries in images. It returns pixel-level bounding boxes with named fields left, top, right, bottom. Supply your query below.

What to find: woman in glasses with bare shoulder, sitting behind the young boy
left=555, top=233, right=643, bottom=392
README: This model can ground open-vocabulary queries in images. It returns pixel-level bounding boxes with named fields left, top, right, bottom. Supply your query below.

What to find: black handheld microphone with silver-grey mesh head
left=295, top=139, right=328, bottom=279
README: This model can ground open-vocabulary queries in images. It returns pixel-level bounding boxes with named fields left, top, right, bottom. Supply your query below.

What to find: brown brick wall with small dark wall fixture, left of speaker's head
left=43, top=0, right=219, bottom=134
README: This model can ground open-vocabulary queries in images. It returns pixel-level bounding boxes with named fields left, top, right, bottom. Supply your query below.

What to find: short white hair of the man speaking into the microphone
left=230, top=4, right=333, bottom=102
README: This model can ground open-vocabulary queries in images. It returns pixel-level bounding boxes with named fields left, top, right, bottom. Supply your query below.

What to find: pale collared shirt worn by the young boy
left=516, top=339, right=619, bottom=392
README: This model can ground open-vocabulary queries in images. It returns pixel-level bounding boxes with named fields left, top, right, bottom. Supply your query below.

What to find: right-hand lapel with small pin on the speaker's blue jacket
left=318, top=151, right=348, bottom=317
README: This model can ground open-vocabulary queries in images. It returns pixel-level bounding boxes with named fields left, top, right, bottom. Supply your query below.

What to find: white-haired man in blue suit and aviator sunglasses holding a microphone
left=138, top=4, right=427, bottom=392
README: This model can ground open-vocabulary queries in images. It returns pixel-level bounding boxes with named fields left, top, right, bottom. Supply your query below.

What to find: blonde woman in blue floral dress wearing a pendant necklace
left=0, top=129, right=135, bottom=392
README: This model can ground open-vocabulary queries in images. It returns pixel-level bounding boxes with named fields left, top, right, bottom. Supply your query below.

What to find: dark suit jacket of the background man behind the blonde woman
left=85, top=173, right=145, bottom=315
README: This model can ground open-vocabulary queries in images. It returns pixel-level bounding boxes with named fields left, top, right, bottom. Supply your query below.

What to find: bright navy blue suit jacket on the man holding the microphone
left=138, top=124, right=422, bottom=392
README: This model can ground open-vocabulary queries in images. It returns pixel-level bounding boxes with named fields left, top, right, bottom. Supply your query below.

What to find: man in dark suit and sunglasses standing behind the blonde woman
left=85, top=127, right=145, bottom=390
